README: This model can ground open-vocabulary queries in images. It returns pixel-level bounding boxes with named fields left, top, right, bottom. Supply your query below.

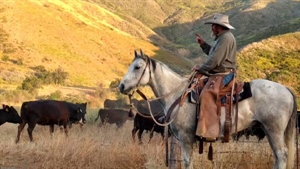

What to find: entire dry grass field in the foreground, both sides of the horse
left=0, top=109, right=296, bottom=169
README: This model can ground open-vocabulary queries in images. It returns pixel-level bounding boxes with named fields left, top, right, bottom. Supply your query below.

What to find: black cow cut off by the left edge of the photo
left=0, top=104, right=22, bottom=126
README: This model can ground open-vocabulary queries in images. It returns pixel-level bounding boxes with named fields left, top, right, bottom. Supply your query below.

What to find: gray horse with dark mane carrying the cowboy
left=119, top=50, right=297, bottom=169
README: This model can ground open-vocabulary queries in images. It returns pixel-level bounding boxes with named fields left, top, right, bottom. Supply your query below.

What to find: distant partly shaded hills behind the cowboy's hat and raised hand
left=92, top=0, right=300, bottom=58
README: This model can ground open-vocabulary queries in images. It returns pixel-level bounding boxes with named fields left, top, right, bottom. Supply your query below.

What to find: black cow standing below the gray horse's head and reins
left=132, top=100, right=165, bottom=143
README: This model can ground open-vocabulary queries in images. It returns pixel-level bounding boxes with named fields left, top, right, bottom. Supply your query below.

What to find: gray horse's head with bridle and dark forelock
left=119, top=50, right=151, bottom=95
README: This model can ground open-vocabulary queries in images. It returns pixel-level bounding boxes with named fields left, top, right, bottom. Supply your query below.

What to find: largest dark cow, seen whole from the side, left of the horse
left=16, top=100, right=86, bottom=143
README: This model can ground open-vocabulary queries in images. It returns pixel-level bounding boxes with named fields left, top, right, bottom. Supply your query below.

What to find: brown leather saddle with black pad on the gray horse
left=180, top=72, right=252, bottom=160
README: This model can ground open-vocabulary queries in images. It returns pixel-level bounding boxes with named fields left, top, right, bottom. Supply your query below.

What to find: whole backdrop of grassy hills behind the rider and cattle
left=0, top=0, right=300, bottom=107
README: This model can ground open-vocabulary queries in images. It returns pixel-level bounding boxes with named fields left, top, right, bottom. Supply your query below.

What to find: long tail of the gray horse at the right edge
left=284, top=89, right=298, bottom=169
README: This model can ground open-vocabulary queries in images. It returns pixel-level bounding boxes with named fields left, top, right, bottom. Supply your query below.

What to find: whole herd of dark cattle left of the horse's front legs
left=0, top=99, right=169, bottom=143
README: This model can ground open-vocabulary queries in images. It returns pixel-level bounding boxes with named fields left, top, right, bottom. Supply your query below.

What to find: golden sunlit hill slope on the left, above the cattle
left=0, top=0, right=190, bottom=86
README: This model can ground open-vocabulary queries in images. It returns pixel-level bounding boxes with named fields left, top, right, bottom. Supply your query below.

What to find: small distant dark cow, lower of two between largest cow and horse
left=95, top=108, right=134, bottom=128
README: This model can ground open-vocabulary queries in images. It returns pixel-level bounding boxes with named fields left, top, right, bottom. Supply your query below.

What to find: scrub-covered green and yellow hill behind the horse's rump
left=238, top=32, right=300, bottom=105
